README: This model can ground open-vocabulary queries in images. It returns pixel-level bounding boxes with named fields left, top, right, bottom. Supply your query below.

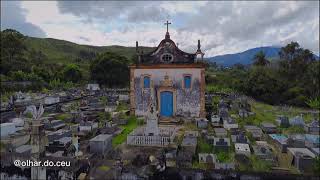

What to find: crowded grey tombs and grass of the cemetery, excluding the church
left=1, top=79, right=320, bottom=177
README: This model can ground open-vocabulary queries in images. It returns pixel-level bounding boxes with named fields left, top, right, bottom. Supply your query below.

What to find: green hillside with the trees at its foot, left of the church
left=0, top=29, right=154, bottom=91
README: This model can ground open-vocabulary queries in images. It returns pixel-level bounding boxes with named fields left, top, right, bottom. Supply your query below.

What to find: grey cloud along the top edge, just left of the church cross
left=58, top=1, right=169, bottom=23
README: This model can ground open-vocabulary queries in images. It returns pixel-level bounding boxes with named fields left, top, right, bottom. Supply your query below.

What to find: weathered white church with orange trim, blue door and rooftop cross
left=130, top=21, right=205, bottom=120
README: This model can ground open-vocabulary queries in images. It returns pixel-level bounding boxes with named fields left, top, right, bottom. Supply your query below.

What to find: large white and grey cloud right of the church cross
left=178, top=1, right=319, bottom=53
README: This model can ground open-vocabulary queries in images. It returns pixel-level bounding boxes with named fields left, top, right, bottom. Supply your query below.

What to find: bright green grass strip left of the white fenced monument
left=112, top=116, right=138, bottom=147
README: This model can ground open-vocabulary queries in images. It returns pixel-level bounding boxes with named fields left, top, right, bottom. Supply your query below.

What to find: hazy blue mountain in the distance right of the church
left=206, top=46, right=319, bottom=67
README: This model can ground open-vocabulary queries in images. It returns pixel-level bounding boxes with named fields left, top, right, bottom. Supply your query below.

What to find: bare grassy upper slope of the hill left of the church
left=25, top=37, right=153, bottom=63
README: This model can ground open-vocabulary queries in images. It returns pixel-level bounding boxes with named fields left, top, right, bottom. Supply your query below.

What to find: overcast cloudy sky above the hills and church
left=1, top=1, right=319, bottom=57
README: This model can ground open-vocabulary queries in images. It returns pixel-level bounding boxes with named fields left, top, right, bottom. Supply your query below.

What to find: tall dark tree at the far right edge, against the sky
left=278, top=42, right=320, bottom=106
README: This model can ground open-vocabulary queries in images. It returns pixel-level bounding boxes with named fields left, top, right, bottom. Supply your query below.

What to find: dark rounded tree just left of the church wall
left=90, top=52, right=130, bottom=87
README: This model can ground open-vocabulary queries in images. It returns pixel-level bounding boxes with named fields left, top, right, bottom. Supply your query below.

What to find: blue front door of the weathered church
left=160, top=91, right=173, bottom=117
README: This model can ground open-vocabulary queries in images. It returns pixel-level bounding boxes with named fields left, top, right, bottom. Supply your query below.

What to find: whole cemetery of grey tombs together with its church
left=0, top=21, right=320, bottom=179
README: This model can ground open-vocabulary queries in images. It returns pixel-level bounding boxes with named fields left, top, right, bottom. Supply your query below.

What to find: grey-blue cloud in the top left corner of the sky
left=1, top=1, right=46, bottom=37
